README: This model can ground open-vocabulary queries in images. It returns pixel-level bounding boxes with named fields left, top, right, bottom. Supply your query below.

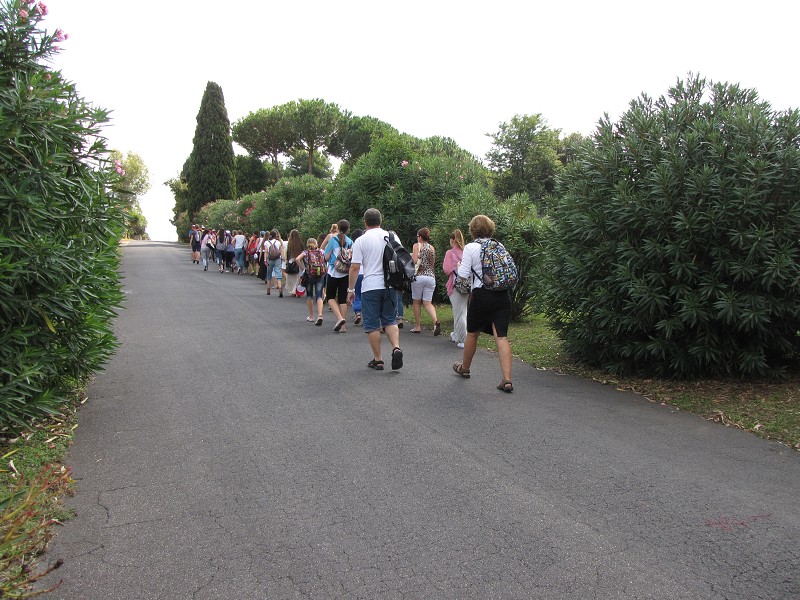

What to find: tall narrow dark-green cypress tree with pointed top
left=186, top=81, right=236, bottom=218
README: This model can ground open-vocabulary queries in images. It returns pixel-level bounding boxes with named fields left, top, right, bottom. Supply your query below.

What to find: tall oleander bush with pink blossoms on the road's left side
left=0, top=0, right=123, bottom=430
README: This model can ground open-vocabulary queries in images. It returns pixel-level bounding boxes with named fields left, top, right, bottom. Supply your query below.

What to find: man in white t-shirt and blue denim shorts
left=347, top=208, right=403, bottom=371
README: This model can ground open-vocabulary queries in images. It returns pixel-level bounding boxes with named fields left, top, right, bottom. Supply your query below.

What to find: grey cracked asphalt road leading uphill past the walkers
left=37, top=242, right=800, bottom=600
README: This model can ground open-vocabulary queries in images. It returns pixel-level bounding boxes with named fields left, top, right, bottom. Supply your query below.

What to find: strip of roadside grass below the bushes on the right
left=432, top=304, right=800, bottom=450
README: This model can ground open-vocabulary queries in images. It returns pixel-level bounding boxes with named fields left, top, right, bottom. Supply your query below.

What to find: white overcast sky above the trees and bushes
left=43, top=0, right=800, bottom=240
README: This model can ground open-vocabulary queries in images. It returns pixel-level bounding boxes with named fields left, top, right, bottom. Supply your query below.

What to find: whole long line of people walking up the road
left=190, top=208, right=514, bottom=393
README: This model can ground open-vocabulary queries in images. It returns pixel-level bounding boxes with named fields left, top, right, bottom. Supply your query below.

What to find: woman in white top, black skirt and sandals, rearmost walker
left=453, top=215, right=514, bottom=393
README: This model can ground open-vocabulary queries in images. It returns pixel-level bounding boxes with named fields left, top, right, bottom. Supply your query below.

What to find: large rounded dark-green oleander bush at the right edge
left=547, top=78, right=800, bottom=377
